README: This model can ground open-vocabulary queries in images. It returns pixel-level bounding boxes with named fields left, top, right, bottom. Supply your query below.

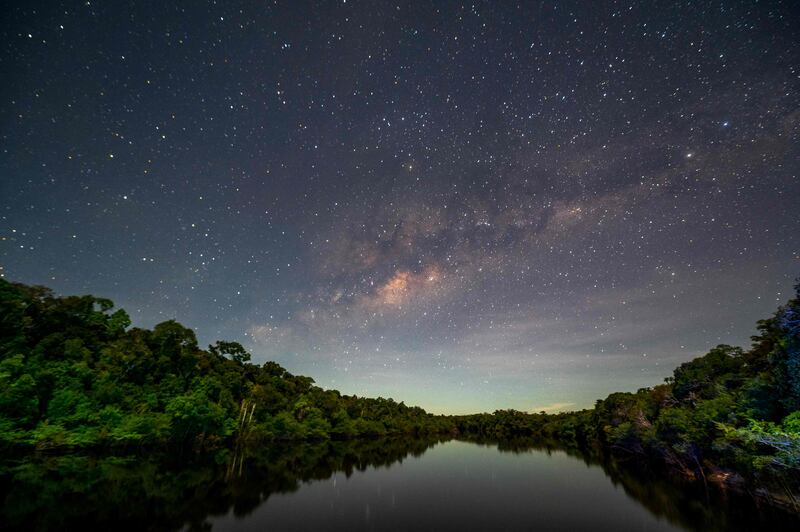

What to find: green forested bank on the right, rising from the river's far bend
left=455, top=283, right=800, bottom=498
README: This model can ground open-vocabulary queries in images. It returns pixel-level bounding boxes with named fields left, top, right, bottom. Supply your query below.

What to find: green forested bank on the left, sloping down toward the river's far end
left=0, top=279, right=452, bottom=449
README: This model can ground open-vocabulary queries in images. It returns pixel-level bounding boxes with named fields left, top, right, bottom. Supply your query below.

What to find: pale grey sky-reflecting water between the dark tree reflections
left=211, top=441, right=680, bottom=532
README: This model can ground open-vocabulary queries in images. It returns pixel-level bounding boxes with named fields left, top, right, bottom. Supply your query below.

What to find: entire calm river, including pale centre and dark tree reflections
left=0, top=439, right=800, bottom=531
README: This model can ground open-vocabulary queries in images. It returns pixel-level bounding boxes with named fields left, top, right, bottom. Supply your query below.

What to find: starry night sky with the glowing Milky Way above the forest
left=0, top=0, right=800, bottom=413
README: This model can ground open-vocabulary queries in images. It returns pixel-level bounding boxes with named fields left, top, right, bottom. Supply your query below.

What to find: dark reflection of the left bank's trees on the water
left=0, top=438, right=439, bottom=531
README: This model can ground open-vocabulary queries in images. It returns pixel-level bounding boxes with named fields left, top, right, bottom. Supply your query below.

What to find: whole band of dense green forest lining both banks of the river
left=0, top=279, right=800, bottom=504
